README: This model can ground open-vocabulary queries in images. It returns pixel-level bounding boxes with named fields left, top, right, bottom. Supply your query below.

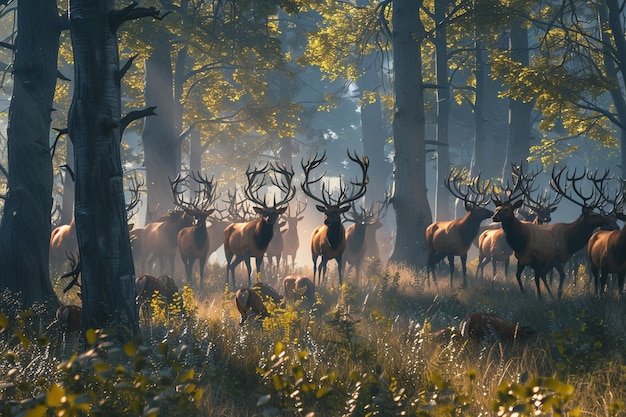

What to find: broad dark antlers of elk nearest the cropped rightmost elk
left=550, top=167, right=609, bottom=209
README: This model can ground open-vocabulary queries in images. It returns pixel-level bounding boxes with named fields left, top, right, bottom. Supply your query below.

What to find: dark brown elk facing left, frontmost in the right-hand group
left=492, top=169, right=556, bottom=297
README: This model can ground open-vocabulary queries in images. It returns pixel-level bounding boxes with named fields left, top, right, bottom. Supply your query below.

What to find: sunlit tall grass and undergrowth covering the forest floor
left=0, top=262, right=626, bottom=416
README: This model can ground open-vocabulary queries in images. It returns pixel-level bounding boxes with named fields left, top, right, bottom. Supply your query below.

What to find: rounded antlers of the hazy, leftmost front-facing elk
left=170, top=172, right=218, bottom=217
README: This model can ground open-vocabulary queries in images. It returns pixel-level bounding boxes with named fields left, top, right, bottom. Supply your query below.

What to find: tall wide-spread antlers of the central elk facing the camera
left=301, top=150, right=369, bottom=207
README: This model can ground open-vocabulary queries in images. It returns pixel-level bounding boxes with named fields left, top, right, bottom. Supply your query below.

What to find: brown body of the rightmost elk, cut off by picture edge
left=587, top=223, right=626, bottom=295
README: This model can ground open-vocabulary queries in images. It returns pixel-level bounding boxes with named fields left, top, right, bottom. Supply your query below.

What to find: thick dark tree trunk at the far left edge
left=0, top=0, right=62, bottom=307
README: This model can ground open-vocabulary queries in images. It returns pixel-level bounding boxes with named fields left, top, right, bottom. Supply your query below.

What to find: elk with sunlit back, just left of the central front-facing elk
left=224, top=164, right=296, bottom=287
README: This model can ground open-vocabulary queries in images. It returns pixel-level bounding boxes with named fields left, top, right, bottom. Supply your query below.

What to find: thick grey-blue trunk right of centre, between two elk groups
left=391, top=0, right=432, bottom=268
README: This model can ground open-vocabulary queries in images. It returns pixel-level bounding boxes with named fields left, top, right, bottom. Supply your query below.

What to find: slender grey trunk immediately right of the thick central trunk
left=435, top=0, right=452, bottom=220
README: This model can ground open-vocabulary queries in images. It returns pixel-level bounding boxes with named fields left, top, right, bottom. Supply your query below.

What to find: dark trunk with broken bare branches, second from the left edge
left=68, top=0, right=138, bottom=339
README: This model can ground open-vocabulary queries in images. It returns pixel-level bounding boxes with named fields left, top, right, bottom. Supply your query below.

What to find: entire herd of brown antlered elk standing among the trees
left=50, top=151, right=626, bottom=327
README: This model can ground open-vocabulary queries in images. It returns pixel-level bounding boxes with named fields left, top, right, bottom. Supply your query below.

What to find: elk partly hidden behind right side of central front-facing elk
left=343, top=195, right=389, bottom=281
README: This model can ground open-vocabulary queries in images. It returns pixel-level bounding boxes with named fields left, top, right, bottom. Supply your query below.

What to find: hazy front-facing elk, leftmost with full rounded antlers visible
left=170, top=172, right=217, bottom=289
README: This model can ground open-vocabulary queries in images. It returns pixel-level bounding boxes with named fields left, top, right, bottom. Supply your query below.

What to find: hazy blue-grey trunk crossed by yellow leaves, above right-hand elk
left=502, top=26, right=533, bottom=181
